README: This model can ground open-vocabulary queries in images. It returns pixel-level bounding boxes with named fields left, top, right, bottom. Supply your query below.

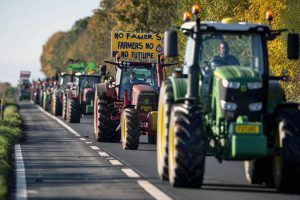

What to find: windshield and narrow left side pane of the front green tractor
left=184, top=33, right=264, bottom=74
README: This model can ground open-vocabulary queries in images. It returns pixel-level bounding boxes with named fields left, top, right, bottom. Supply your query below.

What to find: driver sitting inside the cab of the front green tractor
left=211, top=41, right=240, bottom=66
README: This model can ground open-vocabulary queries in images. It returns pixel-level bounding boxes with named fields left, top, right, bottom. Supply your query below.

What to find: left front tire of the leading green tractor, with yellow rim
left=168, top=104, right=206, bottom=188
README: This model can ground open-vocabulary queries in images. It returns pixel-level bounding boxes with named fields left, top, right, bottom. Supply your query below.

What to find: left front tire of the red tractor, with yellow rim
left=121, top=108, right=140, bottom=150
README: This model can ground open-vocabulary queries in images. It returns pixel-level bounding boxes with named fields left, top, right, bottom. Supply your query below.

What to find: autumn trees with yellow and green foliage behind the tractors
left=41, top=0, right=300, bottom=101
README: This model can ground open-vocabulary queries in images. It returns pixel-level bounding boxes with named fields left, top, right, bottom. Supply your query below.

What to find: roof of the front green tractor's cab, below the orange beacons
left=181, top=21, right=271, bottom=33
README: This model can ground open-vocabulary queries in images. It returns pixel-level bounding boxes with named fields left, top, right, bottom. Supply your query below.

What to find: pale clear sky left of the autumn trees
left=0, top=0, right=100, bottom=85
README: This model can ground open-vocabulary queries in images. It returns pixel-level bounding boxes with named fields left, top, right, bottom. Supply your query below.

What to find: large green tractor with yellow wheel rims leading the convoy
left=157, top=6, right=300, bottom=191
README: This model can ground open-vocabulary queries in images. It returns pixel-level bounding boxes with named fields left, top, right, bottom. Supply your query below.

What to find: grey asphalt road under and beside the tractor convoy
left=16, top=103, right=300, bottom=200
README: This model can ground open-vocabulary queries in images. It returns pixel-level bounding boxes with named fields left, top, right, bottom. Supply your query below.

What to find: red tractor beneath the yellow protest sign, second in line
left=94, top=55, right=172, bottom=149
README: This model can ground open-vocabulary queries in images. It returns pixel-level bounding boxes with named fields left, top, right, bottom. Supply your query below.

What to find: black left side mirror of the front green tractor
left=164, top=30, right=178, bottom=57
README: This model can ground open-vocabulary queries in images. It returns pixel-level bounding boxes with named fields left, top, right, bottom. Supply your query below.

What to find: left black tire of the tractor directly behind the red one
left=67, top=99, right=80, bottom=123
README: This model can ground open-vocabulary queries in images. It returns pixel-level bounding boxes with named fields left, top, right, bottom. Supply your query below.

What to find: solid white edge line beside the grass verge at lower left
left=15, top=144, right=27, bottom=200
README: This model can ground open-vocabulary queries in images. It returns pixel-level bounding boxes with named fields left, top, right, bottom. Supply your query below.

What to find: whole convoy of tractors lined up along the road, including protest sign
left=28, top=5, right=300, bottom=192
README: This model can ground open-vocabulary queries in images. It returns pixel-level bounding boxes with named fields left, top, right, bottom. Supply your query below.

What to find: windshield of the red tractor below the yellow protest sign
left=120, top=66, right=158, bottom=99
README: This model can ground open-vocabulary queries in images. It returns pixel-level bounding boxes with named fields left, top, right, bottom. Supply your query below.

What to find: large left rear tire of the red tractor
left=94, top=96, right=121, bottom=142
